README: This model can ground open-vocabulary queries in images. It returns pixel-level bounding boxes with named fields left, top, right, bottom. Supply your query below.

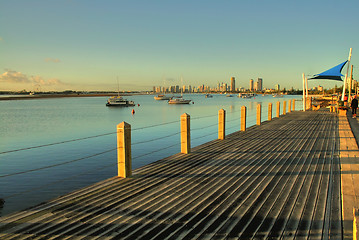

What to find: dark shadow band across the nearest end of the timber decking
left=0, top=203, right=342, bottom=239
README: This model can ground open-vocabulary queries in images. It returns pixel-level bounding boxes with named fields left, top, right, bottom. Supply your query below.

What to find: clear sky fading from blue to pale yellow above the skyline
left=0, top=0, right=359, bottom=91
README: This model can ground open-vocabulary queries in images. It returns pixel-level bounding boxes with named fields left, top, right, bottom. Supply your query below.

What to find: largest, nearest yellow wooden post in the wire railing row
left=117, top=122, right=132, bottom=178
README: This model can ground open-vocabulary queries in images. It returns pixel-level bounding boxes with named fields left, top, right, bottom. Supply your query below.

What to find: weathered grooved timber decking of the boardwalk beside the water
left=0, top=111, right=342, bottom=240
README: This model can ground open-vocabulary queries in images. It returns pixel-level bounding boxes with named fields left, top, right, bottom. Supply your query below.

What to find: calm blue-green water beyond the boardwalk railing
left=0, top=94, right=302, bottom=216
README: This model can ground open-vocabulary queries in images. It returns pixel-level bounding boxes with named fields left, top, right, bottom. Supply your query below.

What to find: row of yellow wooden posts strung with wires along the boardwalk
left=0, top=97, right=300, bottom=214
